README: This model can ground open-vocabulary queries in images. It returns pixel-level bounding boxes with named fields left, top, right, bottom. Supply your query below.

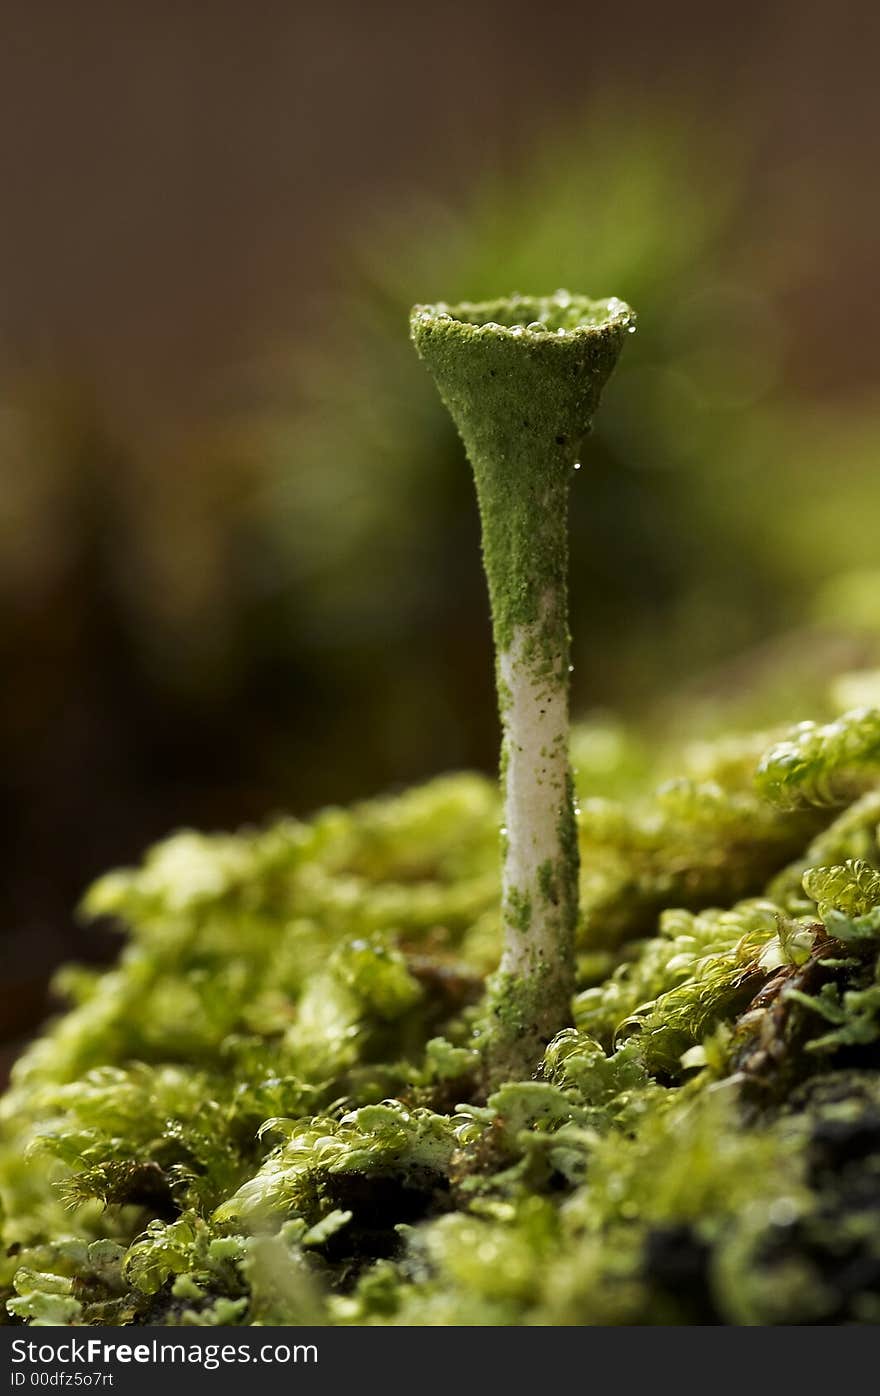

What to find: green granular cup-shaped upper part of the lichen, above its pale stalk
left=411, top=292, right=634, bottom=645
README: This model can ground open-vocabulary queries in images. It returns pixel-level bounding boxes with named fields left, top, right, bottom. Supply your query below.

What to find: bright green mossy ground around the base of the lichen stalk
left=0, top=692, right=880, bottom=1325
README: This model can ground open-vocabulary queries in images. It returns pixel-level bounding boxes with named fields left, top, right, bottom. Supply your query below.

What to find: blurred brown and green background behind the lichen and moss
left=0, top=0, right=880, bottom=1060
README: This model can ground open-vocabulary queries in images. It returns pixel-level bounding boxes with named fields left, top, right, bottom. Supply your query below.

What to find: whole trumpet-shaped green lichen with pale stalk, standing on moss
left=411, top=292, right=634, bottom=1081
